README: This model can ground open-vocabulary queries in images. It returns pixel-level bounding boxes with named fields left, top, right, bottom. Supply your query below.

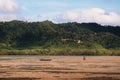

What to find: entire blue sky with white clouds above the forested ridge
left=0, top=0, right=120, bottom=25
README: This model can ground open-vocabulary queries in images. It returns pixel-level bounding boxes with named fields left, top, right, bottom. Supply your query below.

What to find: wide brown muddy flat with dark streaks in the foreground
left=0, top=56, right=120, bottom=80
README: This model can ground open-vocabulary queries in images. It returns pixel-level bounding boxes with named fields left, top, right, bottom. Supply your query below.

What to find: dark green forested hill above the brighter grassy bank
left=0, top=20, right=120, bottom=49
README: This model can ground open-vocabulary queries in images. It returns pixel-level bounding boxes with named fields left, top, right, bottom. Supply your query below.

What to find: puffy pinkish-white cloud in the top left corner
left=0, top=0, right=19, bottom=12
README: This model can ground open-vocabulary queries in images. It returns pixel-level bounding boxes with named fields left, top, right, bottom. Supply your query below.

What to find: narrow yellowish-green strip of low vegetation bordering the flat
left=0, top=49, right=120, bottom=56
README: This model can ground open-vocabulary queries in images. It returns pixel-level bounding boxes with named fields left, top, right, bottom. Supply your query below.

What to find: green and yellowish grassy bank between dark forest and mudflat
left=0, top=43, right=120, bottom=56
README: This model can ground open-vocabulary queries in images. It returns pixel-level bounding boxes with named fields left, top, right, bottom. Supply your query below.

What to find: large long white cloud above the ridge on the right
left=55, top=8, right=120, bottom=25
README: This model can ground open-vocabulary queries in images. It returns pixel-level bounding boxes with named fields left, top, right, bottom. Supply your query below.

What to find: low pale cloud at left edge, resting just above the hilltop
left=0, top=14, right=17, bottom=21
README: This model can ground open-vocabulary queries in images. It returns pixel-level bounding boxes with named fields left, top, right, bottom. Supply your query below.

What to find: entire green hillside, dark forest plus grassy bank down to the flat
left=0, top=20, right=120, bottom=55
